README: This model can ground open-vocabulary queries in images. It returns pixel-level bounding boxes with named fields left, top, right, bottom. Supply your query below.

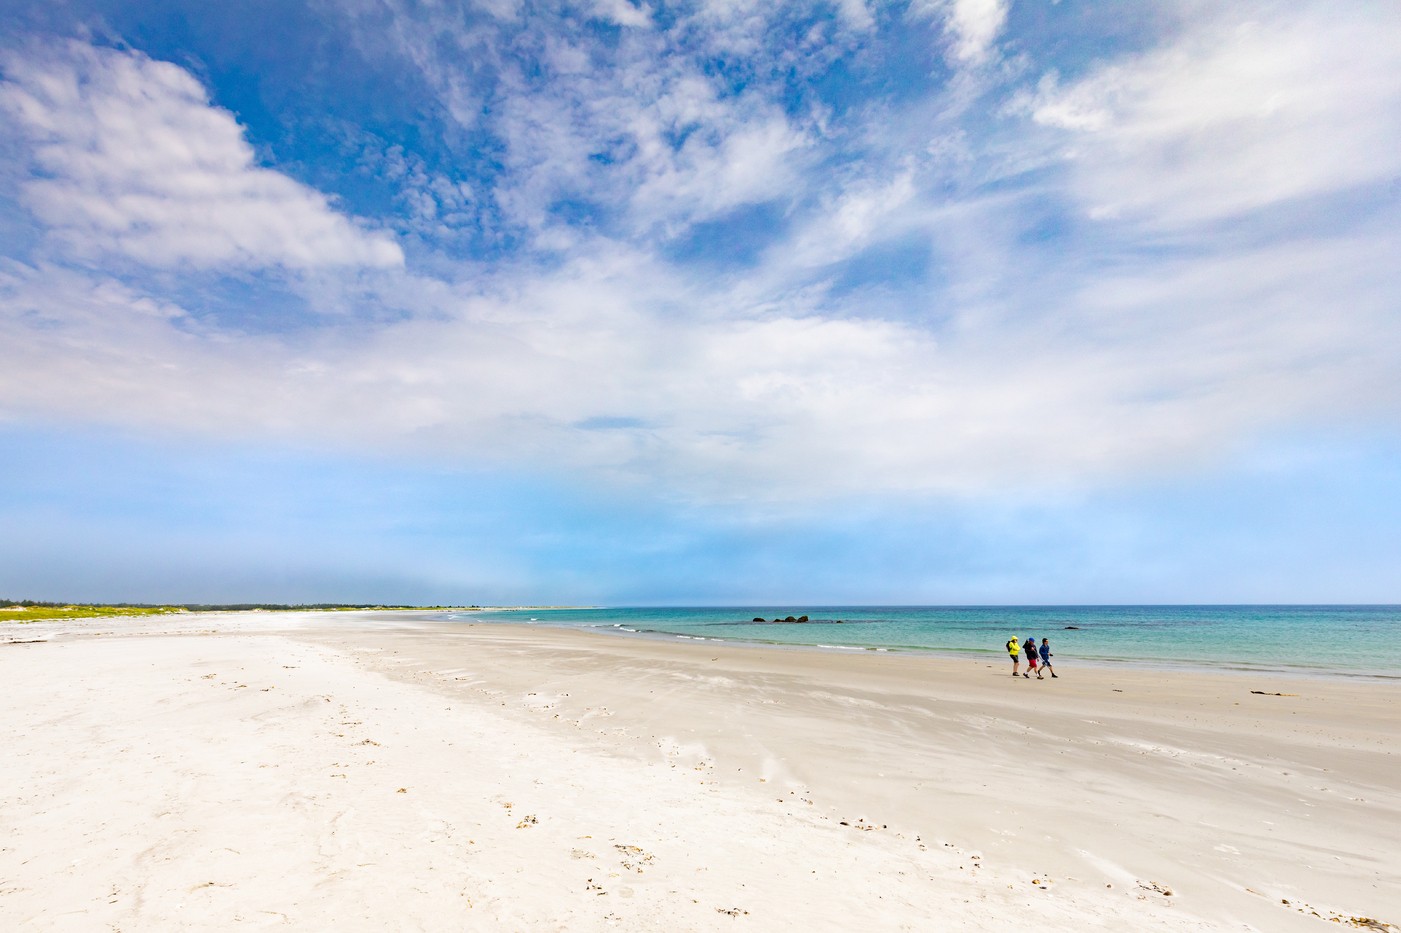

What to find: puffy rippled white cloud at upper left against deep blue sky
left=0, top=42, right=403, bottom=269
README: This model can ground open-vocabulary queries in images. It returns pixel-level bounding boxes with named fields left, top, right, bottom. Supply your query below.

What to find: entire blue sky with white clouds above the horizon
left=0, top=0, right=1401, bottom=608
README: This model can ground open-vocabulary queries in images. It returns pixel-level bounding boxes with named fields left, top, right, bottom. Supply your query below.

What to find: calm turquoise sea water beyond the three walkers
left=444, top=605, right=1401, bottom=677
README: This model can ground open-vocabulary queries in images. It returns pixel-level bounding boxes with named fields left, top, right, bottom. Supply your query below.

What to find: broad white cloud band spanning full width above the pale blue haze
left=0, top=203, right=1401, bottom=500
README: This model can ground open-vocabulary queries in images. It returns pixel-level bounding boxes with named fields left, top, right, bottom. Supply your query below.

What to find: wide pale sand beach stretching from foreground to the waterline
left=0, top=612, right=1401, bottom=932
